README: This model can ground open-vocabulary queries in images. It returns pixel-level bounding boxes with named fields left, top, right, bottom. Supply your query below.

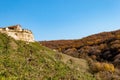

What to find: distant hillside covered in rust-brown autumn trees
left=40, top=30, right=120, bottom=68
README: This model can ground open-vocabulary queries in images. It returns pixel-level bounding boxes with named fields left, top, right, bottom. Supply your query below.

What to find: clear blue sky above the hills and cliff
left=0, top=0, right=120, bottom=41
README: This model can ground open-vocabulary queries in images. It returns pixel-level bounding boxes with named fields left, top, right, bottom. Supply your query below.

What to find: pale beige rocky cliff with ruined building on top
left=0, top=25, right=34, bottom=42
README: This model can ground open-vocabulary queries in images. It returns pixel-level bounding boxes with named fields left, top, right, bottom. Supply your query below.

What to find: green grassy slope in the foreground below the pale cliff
left=0, top=33, right=95, bottom=80
